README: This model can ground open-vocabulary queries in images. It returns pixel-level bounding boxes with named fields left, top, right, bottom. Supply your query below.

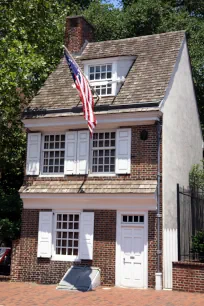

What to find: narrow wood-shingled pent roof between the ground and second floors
left=20, top=180, right=157, bottom=194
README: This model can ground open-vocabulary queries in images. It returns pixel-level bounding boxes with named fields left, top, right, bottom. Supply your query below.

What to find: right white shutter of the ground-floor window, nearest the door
left=79, top=212, right=94, bottom=259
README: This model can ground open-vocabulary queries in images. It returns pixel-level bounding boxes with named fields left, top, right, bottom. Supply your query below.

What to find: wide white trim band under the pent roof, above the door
left=21, top=193, right=157, bottom=211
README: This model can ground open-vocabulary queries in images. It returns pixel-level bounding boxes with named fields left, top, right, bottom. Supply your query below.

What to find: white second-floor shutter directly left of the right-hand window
left=77, top=131, right=89, bottom=174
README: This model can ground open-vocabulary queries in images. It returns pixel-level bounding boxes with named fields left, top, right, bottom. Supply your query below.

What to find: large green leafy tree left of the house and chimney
left=0, top=0, right=85, bottom=243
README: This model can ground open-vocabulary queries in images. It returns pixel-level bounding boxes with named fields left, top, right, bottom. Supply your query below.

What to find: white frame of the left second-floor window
left=39, top=131, right=66, bottom=177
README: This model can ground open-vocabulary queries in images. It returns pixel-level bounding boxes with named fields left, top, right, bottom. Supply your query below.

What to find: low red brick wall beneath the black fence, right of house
left=173, top=262, right=204, bottom=293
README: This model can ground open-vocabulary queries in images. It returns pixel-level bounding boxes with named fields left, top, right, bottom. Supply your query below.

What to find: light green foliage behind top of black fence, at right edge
left=189, top=160, right=204, bottom=191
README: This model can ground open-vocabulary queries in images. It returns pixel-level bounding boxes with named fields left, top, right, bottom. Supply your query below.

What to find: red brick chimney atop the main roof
left=65, top=16, right=94, bottom=54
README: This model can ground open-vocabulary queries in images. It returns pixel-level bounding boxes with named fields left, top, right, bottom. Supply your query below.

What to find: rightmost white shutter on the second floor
left=116, top=129, right=131, bottom=173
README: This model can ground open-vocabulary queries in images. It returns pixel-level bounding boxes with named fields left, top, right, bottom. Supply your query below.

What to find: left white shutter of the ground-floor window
left=37, top=211, right=52, bottom=258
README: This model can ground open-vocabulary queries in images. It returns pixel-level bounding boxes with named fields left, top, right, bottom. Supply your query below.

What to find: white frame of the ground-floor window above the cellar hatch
left=51, top=210, right=82, bottom=262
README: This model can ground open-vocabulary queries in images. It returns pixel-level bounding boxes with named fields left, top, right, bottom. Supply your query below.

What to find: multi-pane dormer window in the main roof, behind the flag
left=88, top=64, right=112, bottom=96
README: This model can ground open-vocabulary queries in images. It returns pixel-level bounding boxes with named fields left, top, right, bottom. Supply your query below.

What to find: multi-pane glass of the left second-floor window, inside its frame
left=42, top=134, right=65, bottom=174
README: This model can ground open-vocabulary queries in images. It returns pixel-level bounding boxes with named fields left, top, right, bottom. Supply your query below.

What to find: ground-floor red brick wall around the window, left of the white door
left=11, top=209, right=116, bottom=285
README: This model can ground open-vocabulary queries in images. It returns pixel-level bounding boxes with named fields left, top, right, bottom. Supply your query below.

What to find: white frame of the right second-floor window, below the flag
left=89, top=129, right=117, bottom=177
